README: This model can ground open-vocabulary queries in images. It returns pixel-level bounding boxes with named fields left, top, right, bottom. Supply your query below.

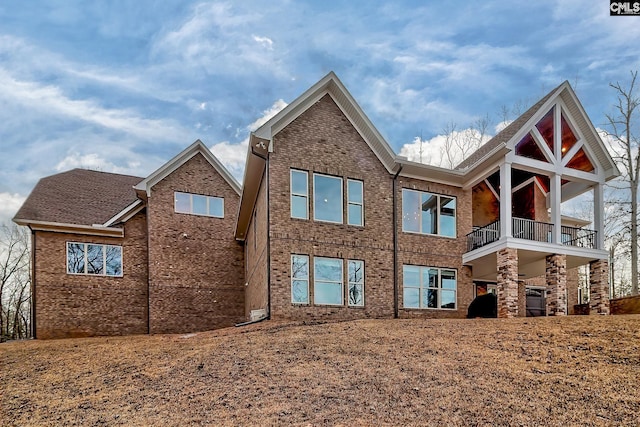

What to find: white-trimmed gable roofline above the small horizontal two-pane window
left=134, top=139, right=242, bottom=197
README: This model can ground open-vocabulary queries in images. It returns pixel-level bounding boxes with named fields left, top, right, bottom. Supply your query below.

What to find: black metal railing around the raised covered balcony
left=467, top=218, right=598, bottom=251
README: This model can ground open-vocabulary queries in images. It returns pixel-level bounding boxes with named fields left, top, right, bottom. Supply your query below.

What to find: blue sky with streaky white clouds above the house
left=0, top=0, right=640, bottom=222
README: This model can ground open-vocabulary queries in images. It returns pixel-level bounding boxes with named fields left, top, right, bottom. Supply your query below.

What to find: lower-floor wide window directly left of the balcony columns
left=402, top=265, right=457, bottom=309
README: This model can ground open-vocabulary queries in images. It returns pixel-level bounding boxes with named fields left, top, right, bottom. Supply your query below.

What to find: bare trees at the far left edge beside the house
left=0, top=224, right=31, bottom=341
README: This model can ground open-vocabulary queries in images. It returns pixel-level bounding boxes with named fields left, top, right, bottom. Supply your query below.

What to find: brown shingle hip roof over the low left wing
left=14, top=169, right=143, bottom=225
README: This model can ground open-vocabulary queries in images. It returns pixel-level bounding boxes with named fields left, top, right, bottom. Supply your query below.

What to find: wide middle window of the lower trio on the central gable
left=313, top=257, right=344, bottom=305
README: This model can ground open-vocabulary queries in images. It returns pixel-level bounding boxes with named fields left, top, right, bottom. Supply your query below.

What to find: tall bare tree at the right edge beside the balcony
left=606, top=71, right=640, bottom=295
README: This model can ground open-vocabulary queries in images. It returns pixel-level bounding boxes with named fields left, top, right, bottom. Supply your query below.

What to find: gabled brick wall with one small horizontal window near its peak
left=148, top=154, right=245, bottom=333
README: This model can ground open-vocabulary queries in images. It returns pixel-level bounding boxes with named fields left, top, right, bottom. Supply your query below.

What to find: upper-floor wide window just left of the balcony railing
left=402, top=188, right=456, bottom=237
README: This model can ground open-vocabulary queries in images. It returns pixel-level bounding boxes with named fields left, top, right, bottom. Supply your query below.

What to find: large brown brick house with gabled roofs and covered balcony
left=14, top=73, right=618, bottom=337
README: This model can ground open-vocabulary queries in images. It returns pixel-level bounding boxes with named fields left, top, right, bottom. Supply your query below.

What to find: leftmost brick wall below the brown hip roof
left=35, top=213, right=147, bottom=339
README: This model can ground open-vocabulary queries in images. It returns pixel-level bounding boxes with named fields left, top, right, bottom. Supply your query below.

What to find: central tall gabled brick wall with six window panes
left=269, top=95, right=393, bottom=319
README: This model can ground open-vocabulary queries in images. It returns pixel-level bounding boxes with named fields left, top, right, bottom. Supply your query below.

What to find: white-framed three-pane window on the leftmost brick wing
left=67, top=242, right=122, bottom=276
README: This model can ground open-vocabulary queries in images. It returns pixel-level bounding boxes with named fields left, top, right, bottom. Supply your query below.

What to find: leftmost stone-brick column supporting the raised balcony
left=496, top=248, right=518, bottom=317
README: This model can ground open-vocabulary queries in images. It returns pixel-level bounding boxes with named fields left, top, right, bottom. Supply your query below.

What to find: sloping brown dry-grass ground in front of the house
left=0, top=315, right=640, bottom=426
